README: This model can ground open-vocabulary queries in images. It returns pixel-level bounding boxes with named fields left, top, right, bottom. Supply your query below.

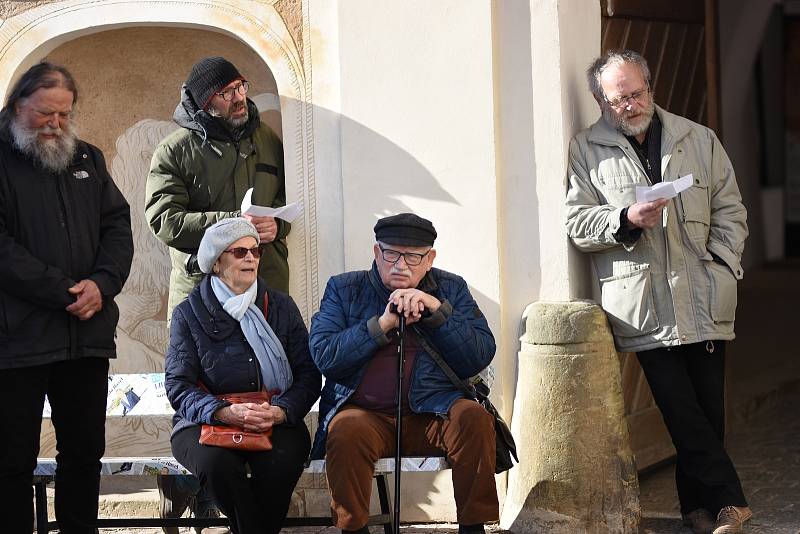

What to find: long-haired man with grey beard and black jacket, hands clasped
left=0, top=63, right=133, bottom=533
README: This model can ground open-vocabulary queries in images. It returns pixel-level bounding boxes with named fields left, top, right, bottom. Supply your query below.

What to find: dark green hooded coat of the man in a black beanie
left=145, top=90, right=291, bottom=319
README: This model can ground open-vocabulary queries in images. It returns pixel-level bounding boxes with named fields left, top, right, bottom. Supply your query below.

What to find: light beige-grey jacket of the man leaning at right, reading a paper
left=566, top=107, right=747, bottom=352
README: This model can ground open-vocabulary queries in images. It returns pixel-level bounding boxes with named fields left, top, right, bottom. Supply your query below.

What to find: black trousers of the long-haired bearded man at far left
left=0, top=356, right=108, bottom=534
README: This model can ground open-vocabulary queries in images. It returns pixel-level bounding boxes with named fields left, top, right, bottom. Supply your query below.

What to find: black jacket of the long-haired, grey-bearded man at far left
left=0, top=136, right=133, bottom=369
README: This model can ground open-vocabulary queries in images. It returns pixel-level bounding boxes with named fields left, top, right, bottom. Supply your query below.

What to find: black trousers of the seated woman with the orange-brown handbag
left=172, top=422, right=311, bottom=534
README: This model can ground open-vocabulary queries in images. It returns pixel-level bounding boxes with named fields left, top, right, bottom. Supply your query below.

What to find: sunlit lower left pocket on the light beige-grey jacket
left=600, top=264, right=661, bottom=337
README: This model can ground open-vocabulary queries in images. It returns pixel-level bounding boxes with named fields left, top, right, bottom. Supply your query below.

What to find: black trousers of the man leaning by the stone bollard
left=636, top=341, right=747, bottom=515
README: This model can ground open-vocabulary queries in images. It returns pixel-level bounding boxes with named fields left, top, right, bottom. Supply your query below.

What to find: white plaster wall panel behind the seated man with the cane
left=338, top=0, right=500, bottom=519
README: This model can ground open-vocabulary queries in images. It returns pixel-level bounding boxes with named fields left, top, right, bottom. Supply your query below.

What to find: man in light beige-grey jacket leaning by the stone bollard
left=566, top=51, right=752, bottom=534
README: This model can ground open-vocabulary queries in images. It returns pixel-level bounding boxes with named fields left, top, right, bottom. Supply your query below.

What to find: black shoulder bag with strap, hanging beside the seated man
left=412, top=327, right=519, bottom=473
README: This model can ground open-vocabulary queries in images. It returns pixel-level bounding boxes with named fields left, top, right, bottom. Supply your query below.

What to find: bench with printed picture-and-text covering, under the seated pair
left=34, top=373, right=450, bottom=534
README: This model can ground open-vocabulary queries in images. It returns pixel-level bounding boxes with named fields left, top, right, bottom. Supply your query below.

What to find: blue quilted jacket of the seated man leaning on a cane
left=310, top=263, right=495, bottom=459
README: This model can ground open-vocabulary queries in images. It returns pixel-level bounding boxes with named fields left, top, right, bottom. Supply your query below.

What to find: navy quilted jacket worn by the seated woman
left=164, top=276, right=322, bottom=435
